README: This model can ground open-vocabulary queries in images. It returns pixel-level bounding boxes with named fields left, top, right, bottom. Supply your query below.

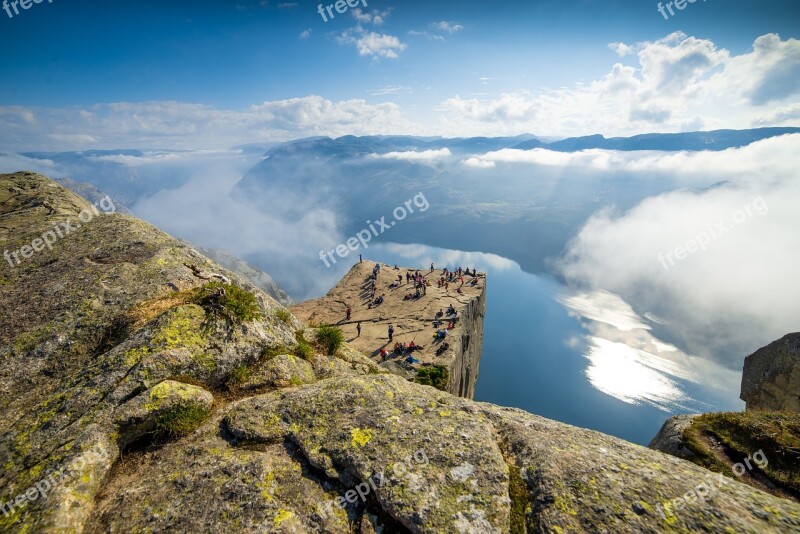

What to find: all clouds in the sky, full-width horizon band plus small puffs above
left=0, top=32, right=800, bottom=151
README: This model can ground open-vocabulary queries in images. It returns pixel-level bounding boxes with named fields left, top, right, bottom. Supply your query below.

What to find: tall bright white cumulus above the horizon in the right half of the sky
left=437, top=32, right=800, bottom=136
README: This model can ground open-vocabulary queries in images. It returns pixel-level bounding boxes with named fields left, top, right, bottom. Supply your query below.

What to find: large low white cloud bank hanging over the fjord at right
left=560, top=135, right=800, bottom=372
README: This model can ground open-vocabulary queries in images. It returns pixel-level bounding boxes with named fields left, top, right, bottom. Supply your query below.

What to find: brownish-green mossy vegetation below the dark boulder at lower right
left=683, top=411, right=800, bottom=493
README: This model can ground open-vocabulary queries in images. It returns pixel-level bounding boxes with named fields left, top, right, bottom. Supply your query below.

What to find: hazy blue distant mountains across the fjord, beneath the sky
left=9, top=128, right=800, bottom=278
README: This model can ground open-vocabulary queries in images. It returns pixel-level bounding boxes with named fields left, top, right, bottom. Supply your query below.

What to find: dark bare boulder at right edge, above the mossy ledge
left=740, top=333, right=800, bottom=412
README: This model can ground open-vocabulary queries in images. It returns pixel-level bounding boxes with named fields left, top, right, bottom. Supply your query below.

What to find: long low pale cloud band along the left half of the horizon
left=0, top=95, right=423, bottom=151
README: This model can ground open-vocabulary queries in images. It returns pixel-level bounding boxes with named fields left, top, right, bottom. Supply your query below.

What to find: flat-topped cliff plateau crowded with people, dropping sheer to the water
left=291, top=261, right=486, bottom=399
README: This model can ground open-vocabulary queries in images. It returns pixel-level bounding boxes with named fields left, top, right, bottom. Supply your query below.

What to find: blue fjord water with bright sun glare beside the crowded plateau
left=354, top=245, right=742, bottom=445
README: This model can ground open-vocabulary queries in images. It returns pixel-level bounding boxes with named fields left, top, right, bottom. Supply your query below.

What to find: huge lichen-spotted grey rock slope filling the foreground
left=0, top=173, right=800, bottom=533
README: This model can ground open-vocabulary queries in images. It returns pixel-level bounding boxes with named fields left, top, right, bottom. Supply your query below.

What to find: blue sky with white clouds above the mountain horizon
left=0, top=0, right=800, bottom=151
